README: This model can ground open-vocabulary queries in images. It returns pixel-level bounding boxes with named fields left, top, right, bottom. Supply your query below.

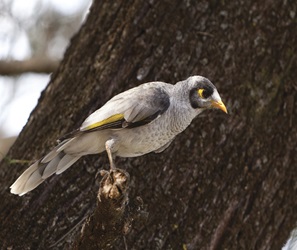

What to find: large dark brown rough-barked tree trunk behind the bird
left=0, top=0, right=297, bottom=249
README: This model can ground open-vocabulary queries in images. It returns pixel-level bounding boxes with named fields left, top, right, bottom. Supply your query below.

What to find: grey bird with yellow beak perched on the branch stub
left=10, top=76, right=227, bottom=196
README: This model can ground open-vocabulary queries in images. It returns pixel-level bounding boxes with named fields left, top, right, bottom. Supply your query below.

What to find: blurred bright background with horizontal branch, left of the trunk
left=0, top=0, right=91, bottom=160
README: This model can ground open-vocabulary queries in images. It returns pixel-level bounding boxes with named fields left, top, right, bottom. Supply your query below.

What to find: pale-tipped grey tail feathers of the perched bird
left=10, top=138, right=80, bottom=196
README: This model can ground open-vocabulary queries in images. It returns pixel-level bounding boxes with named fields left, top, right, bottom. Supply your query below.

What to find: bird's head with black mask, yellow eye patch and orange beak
left=186, top=76, right=228, bottom=113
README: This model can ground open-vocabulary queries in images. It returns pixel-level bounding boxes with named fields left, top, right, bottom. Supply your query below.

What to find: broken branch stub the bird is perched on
left=73, top=169, right=147, bottom=250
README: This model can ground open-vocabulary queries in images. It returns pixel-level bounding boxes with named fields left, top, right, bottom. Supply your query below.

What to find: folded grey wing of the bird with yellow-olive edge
left=80, top=82, right=172, bottom=132
